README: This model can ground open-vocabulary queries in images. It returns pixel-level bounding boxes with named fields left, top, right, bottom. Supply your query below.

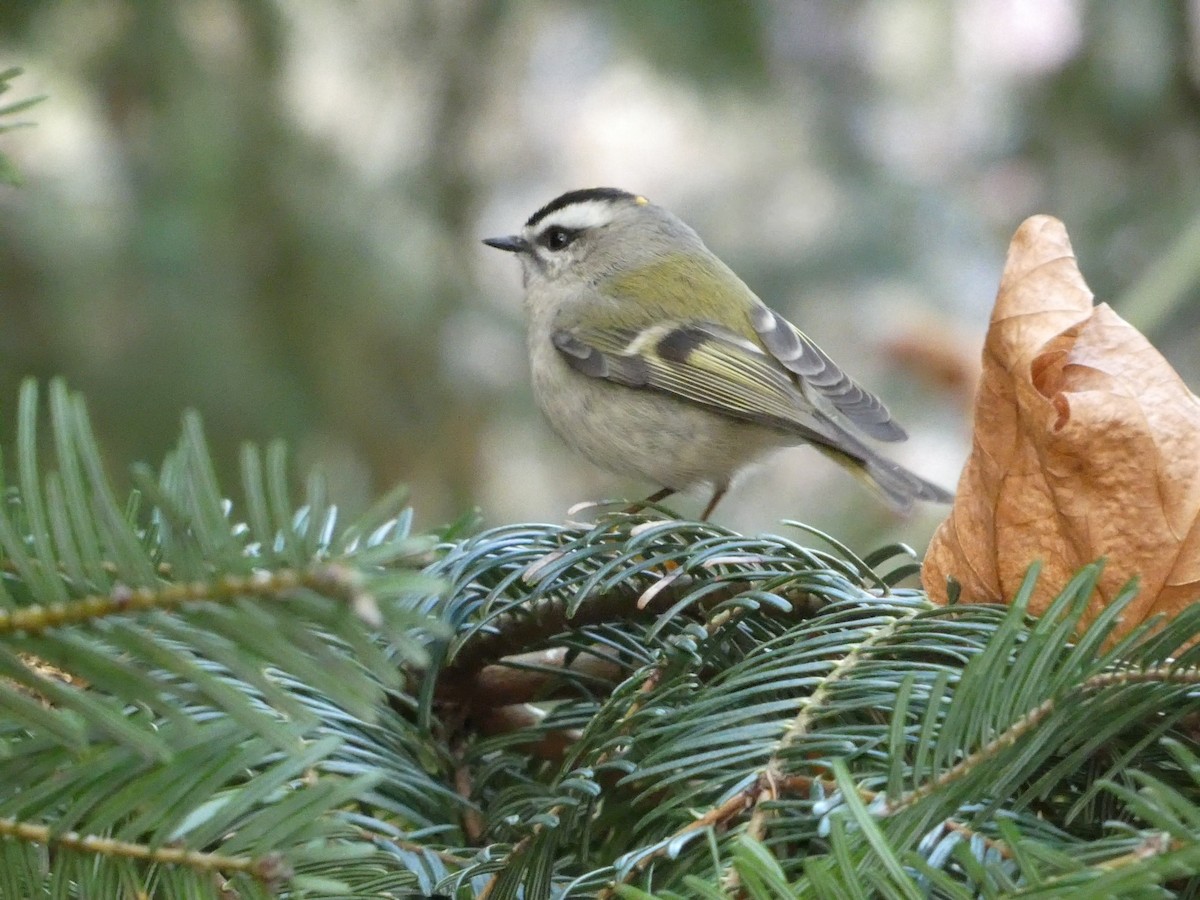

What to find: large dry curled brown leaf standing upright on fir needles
left=922, top=216, right=1200, bottom=631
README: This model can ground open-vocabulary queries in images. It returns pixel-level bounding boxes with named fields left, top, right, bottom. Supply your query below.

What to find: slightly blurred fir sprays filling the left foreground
left=0, top=382, right=458, bottom=896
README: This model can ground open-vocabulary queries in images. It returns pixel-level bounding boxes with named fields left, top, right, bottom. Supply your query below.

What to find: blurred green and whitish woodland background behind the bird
left=0, top=0, right=1200, bottom=544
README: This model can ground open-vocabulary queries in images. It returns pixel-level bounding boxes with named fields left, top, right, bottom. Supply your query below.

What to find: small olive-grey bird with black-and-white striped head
left=484, top=187, right=952, bottom=518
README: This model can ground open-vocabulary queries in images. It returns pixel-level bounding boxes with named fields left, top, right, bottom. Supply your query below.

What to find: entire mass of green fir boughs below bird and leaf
left=0, top=382, right=1200, bottom=900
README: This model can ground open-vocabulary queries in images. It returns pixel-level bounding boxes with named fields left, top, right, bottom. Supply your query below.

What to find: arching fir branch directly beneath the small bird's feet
left=431, top=515, right=840, bottom=702
